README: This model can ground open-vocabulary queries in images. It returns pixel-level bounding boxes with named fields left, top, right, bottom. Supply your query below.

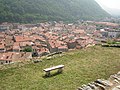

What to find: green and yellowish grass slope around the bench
left=0, top=46, right=120, bottom=90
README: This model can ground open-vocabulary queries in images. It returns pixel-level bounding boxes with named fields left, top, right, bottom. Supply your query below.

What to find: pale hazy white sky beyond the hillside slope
left=96, top=0, right=120, bottom=9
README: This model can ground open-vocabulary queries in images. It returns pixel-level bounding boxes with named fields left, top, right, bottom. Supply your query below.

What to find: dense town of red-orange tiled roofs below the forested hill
left=0, top=21, right=120, bottom=64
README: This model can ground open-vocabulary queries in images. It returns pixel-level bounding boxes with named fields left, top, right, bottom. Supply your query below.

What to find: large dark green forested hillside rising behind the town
left=0, top=0, right=109, bottom=23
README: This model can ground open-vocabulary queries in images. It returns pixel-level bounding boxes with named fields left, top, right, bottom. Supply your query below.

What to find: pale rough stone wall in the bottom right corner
left=77, top=72, right=120, bottom=90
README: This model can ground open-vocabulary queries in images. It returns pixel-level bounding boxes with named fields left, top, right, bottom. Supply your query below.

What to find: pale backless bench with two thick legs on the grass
left=43, top=65, right=64, bottom=76
